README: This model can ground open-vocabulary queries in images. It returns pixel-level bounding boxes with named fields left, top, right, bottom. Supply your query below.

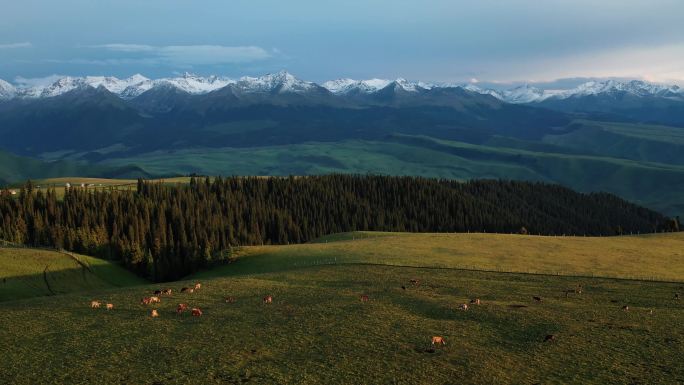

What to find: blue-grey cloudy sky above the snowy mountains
left=0, top=0, right=684, bottom=85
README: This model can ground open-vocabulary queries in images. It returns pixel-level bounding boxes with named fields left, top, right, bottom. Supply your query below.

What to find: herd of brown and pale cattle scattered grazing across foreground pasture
left=90, top=279, right=680, bottom=351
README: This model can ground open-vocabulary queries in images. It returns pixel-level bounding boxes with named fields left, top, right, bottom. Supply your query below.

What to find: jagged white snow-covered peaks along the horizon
left=0, top=71, right=684, bottom=104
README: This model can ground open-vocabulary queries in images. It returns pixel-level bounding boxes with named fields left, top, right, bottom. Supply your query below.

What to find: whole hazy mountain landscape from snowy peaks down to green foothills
left=0, top=71, right=684, bottom=218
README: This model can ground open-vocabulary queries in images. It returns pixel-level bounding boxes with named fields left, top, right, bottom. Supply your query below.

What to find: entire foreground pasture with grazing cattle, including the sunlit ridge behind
left=0, top=233, right=684, bottom=385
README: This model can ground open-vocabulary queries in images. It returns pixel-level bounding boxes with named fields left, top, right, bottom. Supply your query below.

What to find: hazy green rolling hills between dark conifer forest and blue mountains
left=96, top=135, right=684, bottom=219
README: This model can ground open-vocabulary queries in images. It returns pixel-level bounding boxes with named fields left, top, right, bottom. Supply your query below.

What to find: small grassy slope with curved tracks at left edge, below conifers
left=0, top=247, right=146, bottom=302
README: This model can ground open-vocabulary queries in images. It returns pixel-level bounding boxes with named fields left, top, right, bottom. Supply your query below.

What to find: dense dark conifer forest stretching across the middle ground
left=0, top=175, right=674, bottom=281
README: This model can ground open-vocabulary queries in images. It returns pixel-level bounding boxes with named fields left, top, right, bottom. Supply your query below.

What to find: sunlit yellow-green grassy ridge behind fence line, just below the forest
left=198, top=232, right=684, bottom=282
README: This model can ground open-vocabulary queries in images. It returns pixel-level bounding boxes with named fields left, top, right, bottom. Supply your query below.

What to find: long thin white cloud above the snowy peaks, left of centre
left=91, top=43, right=276, bottom=65
